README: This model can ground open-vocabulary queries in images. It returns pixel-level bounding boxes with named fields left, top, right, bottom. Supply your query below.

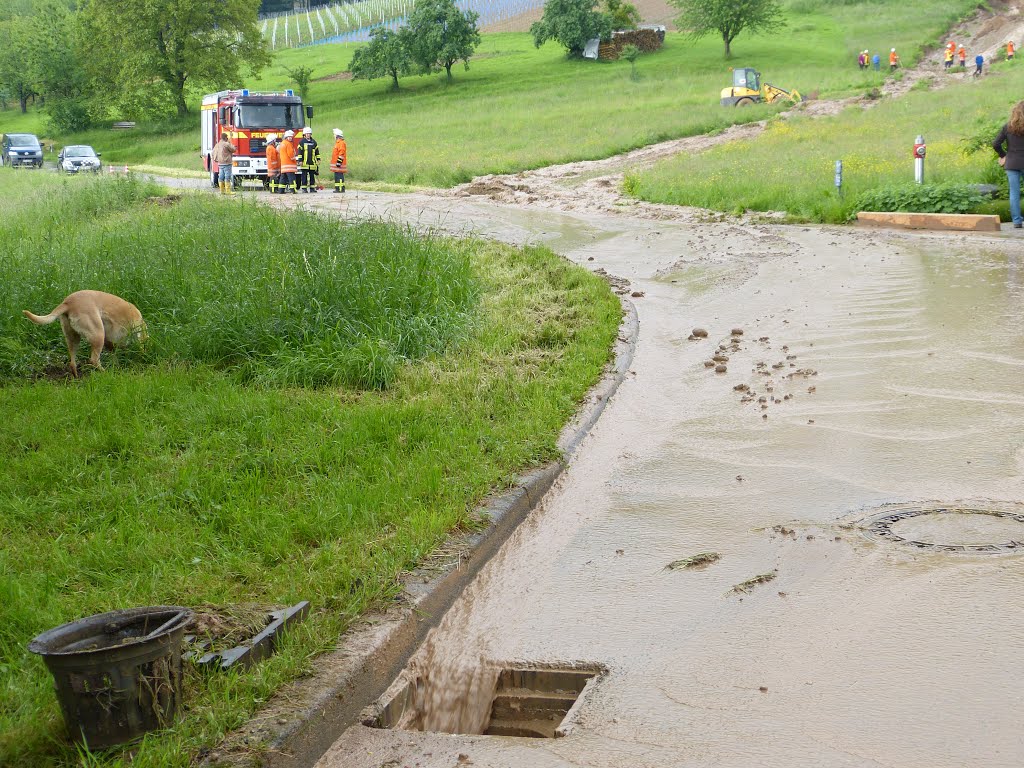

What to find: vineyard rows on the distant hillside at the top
left=262, top=0, right=544, bottom=50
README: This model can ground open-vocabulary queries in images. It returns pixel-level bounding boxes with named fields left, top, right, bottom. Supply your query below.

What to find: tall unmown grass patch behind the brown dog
left=0, top=171, right=477, bottom=387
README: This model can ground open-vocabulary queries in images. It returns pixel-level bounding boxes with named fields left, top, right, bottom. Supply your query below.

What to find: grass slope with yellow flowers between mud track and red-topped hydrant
left=626, top=63, right=1024, bottom=222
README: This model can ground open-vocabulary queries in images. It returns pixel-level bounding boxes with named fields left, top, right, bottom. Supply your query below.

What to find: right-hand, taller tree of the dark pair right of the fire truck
left=406, top=0, right=480, bottom=82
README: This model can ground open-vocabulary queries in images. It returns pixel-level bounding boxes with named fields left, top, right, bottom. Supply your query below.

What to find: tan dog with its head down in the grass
left=22, top=291, right=147, bottom=376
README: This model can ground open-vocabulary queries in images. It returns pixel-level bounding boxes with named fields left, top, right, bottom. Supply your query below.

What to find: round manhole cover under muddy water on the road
left=861, top=504, right=1024, bottom=555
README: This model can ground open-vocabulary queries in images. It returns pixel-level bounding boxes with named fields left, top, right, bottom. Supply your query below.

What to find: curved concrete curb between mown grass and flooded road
left=202, top=297, right=640, bottom=768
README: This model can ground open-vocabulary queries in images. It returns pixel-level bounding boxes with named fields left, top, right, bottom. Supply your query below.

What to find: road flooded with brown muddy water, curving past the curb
left=249, top=188, right=1024, bottom=768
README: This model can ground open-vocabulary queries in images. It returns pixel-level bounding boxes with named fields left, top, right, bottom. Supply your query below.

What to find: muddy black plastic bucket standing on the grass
left=29, top=605, right=191, bottom=750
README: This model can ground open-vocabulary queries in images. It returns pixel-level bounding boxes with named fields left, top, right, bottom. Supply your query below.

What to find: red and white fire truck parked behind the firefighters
left=200, top=89, right=313, bottom=186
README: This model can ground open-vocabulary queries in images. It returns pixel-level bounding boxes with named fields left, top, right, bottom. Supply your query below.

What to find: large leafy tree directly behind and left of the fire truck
left=81, top=0, right=270, bottom=117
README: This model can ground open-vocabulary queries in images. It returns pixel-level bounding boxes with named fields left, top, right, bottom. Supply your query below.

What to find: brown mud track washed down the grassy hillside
left=452, top=2, right=1024, bottom=221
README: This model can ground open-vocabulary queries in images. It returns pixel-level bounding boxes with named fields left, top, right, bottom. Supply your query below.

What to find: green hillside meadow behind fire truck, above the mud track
left=0, top=0, right=975, bottom=186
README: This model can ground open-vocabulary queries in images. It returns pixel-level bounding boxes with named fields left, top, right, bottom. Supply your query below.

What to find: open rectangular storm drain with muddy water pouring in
left=362, top=669, right=602, bottom=738
